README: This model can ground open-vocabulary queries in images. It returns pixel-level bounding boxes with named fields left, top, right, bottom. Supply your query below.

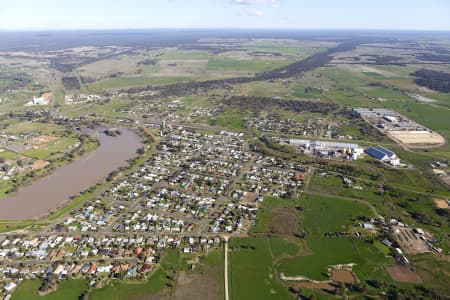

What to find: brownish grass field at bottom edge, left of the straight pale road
left=173, top=268, right=222, bottom=300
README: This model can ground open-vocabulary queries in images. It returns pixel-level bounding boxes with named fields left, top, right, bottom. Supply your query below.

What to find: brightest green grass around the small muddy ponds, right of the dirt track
left=278, top=195, right=392, bottom=280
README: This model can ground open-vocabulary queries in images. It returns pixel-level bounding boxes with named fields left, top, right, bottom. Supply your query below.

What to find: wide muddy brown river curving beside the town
left=0, top=129, right=142, bottom=220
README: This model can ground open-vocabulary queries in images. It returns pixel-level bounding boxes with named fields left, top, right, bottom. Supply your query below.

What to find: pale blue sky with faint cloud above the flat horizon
left=0, top=0, right=450, bottom=30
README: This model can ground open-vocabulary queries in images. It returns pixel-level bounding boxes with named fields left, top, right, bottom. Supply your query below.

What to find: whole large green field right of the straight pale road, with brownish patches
left=230, top=195, right=393, bottom=299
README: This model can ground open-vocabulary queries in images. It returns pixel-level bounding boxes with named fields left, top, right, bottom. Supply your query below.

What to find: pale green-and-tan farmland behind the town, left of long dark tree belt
left=75, top=44, right=306, bottom=92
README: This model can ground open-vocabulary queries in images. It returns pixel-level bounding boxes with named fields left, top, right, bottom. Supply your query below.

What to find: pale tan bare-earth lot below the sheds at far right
left=388, top=130, right=445, bottom=148
